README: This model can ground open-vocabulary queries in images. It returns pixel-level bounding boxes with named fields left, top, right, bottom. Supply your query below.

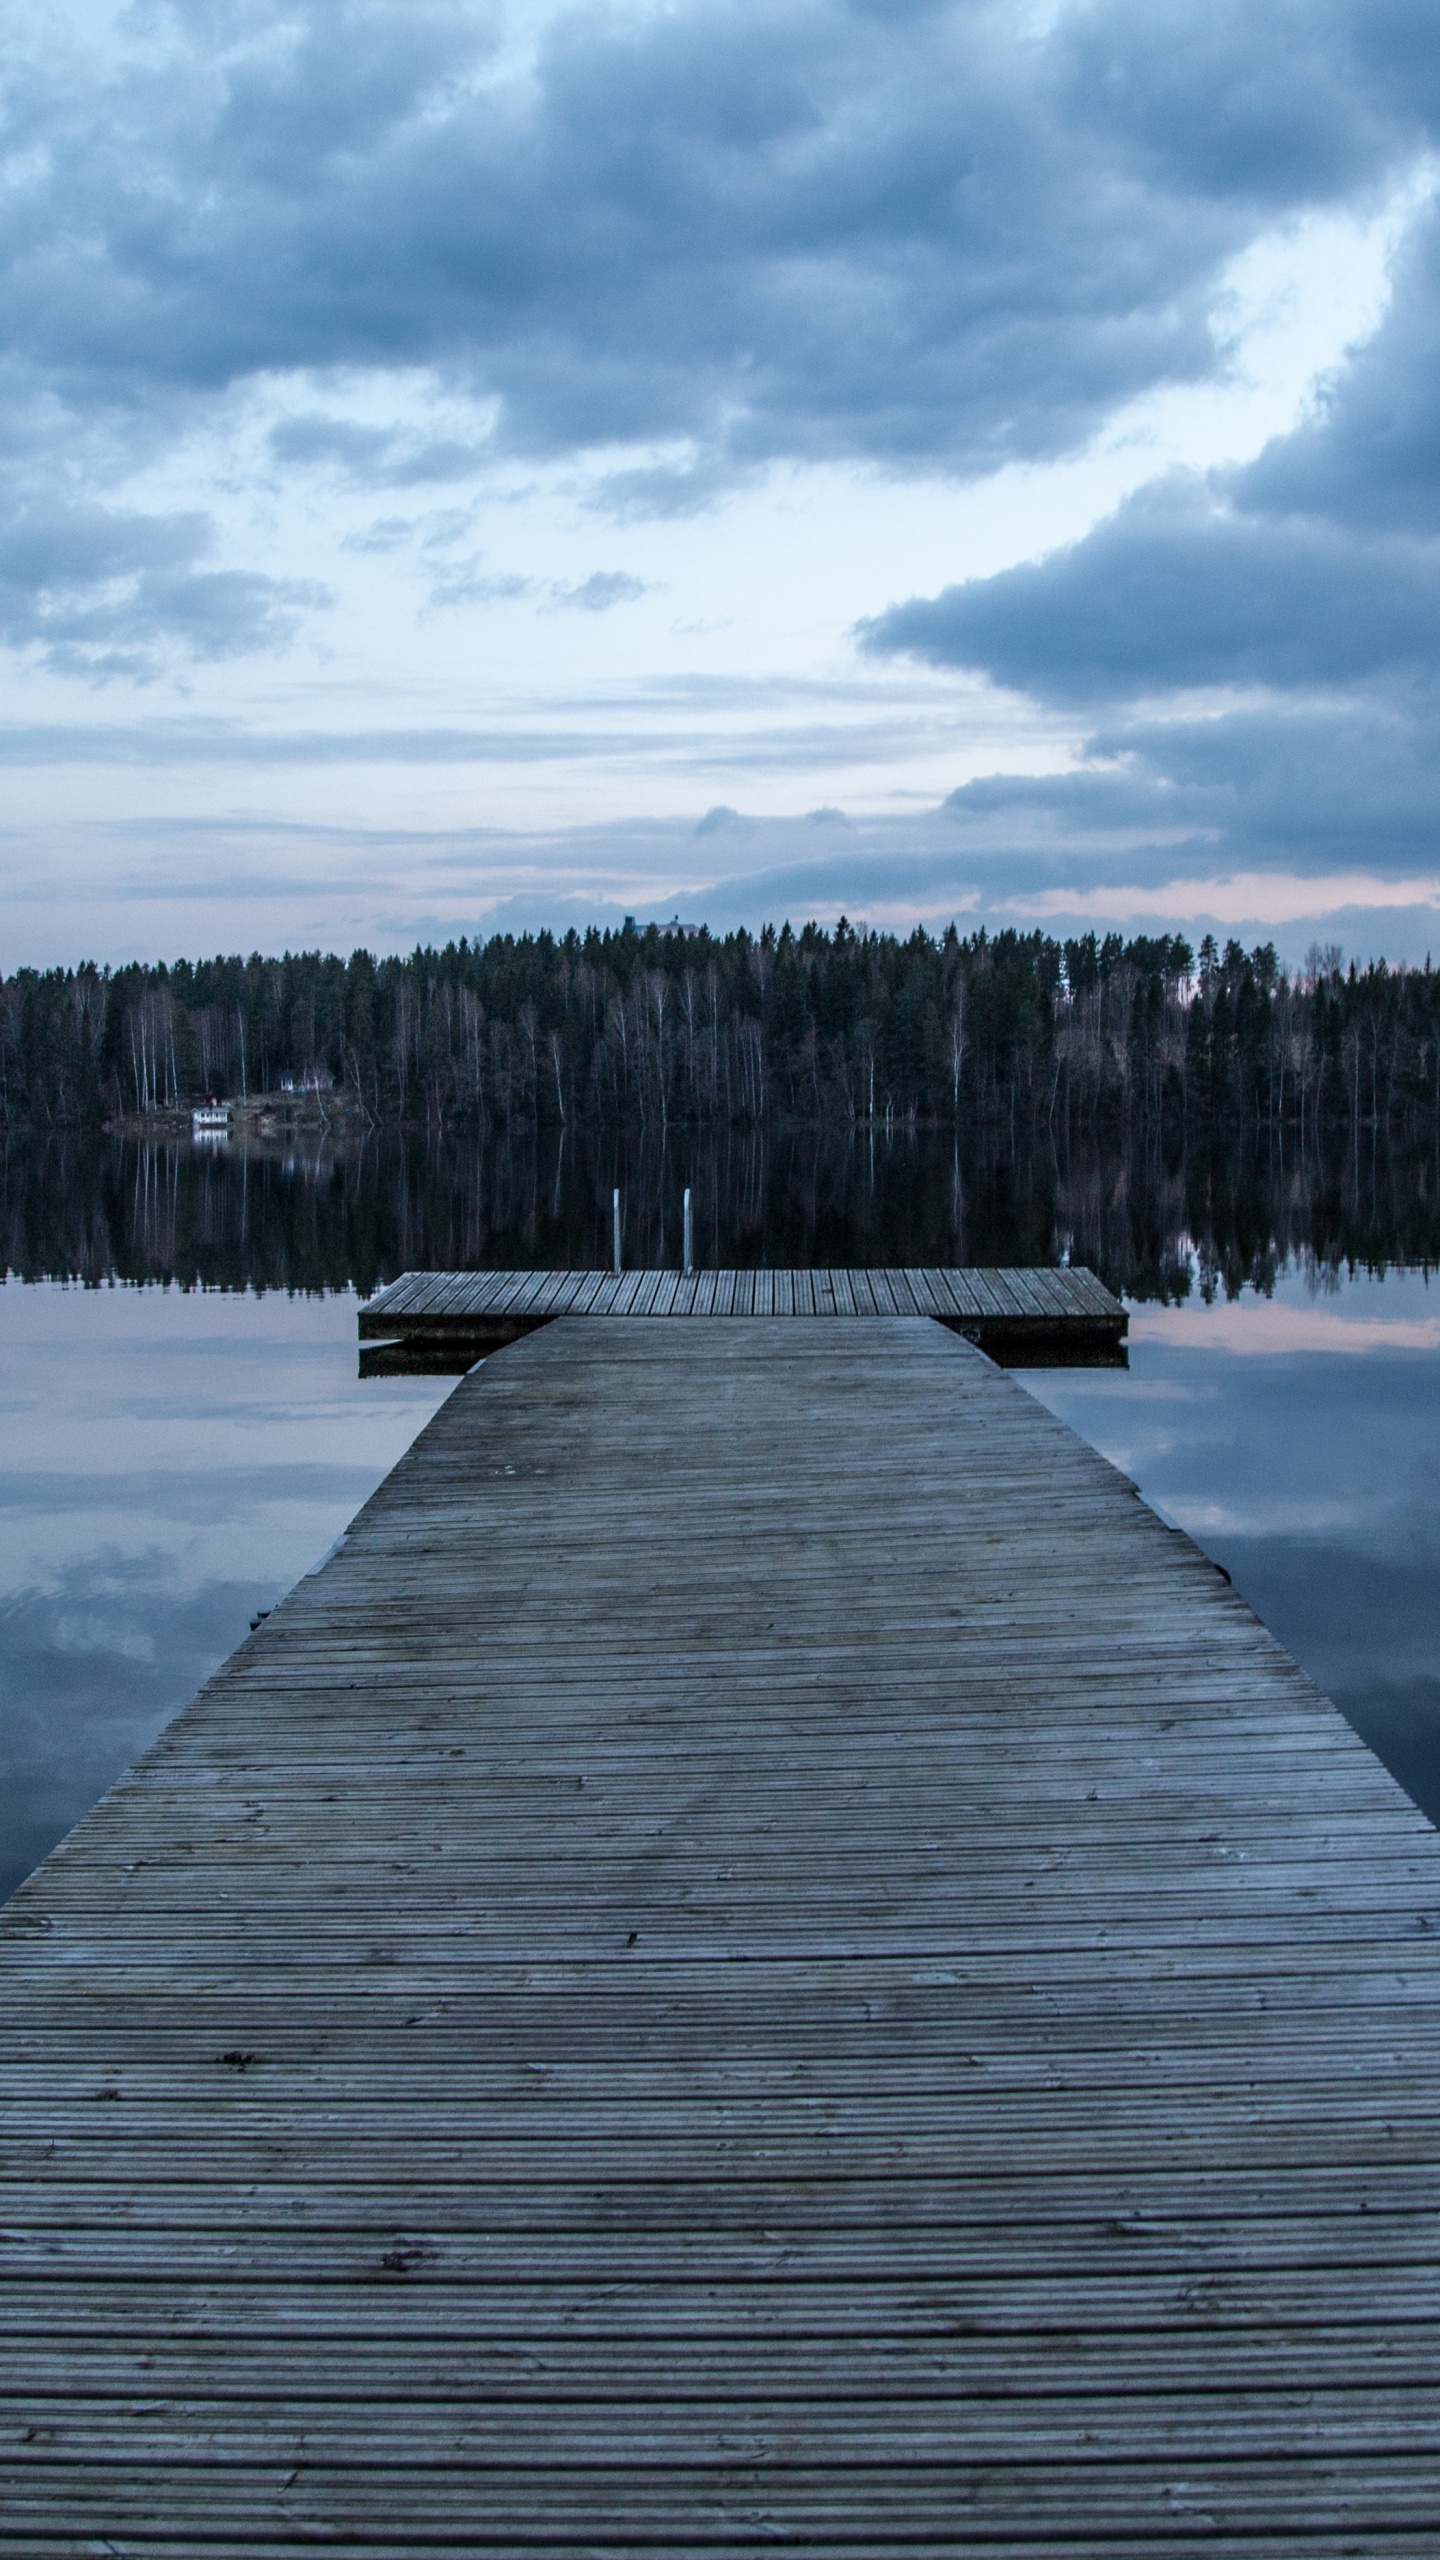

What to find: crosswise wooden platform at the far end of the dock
left=359, top=1265, right=1130, bottom=1375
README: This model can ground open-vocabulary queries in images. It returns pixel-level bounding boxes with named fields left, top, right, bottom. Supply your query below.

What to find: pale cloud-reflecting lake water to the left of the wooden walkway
left=0, top=1285, right=448, bottom=1894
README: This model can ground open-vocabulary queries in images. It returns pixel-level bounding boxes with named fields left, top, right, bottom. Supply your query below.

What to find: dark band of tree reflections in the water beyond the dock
left=0, top=1124, right=1440, bottom=1298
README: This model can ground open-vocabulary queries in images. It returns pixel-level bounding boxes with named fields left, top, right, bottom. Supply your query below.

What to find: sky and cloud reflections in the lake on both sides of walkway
left=0, top=1272, right=1440, bottom=1892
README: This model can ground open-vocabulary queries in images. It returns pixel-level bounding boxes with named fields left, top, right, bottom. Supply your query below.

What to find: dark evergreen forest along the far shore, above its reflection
left=0, top=919, right=1440, bottom=1139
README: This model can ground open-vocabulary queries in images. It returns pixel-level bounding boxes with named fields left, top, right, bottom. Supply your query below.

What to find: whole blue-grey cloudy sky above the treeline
left=0, top=0, right=1440, bottom=968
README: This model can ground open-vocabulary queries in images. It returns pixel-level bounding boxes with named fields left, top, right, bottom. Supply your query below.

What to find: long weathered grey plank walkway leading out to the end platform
left=0, top=1316, right=1440, bottom=2560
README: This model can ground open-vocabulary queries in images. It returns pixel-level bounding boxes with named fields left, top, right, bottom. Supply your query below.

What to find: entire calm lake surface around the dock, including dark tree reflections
left=0, top=1121, right=1440, bottom=1892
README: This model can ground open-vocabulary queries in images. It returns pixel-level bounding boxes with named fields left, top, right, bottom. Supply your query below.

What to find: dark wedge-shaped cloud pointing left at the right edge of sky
left=863, top=177, right=1440, bottom=721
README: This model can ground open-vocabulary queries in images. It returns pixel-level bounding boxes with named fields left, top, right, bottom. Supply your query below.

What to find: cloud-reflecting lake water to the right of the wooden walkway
left=1025, top=1270, right=1440, bottom=1820
